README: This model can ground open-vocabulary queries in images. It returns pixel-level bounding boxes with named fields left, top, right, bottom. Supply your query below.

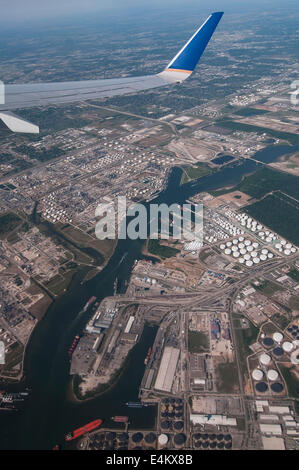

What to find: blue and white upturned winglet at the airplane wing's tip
left=158, top=12, right=223, bottom=82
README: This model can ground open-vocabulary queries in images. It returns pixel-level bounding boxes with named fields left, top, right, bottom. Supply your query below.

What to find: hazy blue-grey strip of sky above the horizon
left=0, top=0, right=296, bottom=25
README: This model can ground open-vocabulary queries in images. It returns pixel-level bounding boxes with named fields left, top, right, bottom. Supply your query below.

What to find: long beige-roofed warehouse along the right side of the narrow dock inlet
left=155, top=346, right=180, bottom=392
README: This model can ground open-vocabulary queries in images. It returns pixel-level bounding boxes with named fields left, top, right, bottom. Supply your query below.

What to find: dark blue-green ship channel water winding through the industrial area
left=0, top=143, right=296, bottom=450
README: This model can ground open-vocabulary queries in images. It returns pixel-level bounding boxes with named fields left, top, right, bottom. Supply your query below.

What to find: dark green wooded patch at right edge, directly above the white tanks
left=245, top=194, right=299, bottom=245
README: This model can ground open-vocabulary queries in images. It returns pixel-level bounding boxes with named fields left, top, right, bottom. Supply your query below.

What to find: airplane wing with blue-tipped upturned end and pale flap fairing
left=0, top=12, right=223, bottom=133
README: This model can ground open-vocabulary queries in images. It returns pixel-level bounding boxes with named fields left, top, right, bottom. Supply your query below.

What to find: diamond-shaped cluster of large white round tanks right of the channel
left=219, top=236, right=274, bottom=267
